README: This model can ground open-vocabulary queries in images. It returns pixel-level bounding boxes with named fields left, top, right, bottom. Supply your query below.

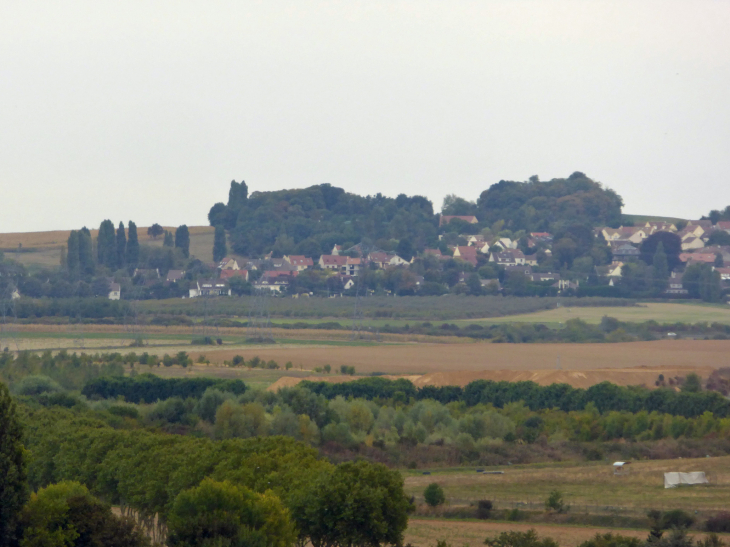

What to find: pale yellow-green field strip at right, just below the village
left=464, top=302, right=730, bottom=325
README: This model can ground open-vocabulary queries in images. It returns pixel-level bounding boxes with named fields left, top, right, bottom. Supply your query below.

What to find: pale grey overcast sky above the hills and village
left=0, top=0, right=730, bottom=232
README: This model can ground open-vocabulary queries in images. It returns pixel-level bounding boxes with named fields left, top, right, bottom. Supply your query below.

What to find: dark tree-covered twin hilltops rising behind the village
left=208, top=176, right=622, bottom=262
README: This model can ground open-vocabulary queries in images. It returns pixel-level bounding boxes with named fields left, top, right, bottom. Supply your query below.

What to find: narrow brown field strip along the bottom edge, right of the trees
left=405, top=518, right=727, bottom=547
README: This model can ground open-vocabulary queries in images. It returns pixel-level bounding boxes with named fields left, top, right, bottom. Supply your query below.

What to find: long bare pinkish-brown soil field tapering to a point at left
left=182, top=340, right=730, bottom=375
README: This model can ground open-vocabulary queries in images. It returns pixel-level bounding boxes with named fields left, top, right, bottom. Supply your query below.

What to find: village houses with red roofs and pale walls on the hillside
left=101, top=215, right=730, bottom=300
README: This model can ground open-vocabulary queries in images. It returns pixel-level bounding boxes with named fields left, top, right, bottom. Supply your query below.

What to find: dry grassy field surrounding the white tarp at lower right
left=403, top=456, right=730, bottom=514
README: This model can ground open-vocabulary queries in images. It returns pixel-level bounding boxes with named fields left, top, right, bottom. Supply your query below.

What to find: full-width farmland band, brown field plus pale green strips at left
left=5, top=325, right=730, bottom=388
